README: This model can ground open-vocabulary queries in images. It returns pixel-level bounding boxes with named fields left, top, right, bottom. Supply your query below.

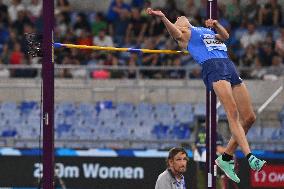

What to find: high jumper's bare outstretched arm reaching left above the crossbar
left=146, top=8, right=182, bottom=41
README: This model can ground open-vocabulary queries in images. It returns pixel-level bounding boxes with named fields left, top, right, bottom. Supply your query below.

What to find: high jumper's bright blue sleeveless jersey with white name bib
left=187, top=27, right=228, bottom=64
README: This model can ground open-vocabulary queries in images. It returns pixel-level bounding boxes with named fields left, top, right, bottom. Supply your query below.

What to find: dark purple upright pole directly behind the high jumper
left=206, top=0, right=217, bottom=189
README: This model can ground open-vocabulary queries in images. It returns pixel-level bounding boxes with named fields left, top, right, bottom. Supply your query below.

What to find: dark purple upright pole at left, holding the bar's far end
left=42, top=0, right=54, bottom=189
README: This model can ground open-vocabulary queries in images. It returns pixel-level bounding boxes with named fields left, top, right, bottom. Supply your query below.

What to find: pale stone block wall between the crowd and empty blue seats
left=0, top=79, right=284, bottom=111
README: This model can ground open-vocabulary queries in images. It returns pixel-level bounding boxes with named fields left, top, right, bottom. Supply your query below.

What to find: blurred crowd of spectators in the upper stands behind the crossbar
left=0, top=0, right=284, bottom=79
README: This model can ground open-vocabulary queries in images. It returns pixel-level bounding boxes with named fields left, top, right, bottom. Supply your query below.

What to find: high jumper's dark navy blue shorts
left=202, top=58, right=242, bottom=91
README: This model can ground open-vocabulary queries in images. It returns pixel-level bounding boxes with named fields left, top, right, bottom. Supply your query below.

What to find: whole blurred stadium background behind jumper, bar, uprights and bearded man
left=0, top=0, right=284, bottom=189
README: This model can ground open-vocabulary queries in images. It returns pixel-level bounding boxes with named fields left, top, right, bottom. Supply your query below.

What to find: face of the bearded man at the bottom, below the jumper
left=169, top=152, right=188, bottom=174
